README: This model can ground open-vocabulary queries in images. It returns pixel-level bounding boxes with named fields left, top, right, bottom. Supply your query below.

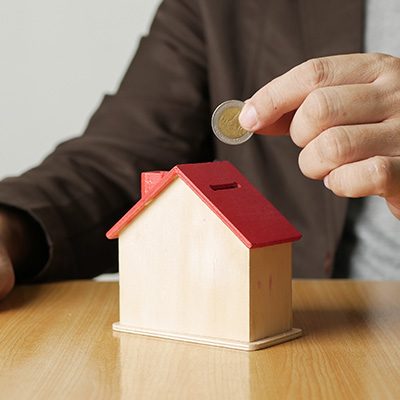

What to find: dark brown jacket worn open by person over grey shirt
left=0, top=0, right=363, bottom=281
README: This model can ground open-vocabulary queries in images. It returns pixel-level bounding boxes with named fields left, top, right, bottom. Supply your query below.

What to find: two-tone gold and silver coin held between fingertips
left=211, top=100, right=253, bottom=144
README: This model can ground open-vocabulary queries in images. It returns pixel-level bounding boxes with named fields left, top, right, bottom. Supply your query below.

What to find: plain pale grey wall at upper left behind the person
left=0, top=0, right=160, bottom=178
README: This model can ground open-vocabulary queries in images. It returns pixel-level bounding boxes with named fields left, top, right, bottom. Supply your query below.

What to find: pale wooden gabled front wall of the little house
left=119, top=177, right=249, bottom=341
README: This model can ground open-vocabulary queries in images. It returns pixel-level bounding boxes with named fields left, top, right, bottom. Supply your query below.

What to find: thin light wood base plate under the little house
left=113, top=322, right=302, bottom=351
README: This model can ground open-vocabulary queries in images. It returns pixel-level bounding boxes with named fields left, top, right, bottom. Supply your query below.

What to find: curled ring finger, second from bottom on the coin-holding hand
left=299, top=120, right=400, bottom=179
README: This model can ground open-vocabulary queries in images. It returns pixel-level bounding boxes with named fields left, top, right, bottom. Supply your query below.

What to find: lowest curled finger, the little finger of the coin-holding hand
left=324, top=156, right=400, bottom=200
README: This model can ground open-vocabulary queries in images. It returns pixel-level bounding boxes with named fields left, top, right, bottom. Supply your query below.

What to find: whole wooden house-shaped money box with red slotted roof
left=107, top=161, right=301, bottom=350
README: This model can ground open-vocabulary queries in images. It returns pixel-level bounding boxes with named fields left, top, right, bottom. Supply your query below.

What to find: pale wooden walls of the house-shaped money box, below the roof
left=115, top=178, right=298, bottom=349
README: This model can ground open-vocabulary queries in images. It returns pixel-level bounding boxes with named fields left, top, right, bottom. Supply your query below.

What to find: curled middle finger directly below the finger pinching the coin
left=290, top=84, right=391, bottom=147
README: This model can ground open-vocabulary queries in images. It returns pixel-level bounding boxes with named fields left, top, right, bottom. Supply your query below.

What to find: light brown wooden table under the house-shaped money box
left=0, top=281, right=400, bottom=400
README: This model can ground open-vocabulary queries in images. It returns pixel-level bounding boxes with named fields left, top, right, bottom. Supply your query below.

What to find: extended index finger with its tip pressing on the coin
left=239, top=54, right=381, bottom=132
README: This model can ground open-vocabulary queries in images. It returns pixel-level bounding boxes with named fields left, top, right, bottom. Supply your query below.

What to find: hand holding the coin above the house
left=239, top=54, right=400, bottom=219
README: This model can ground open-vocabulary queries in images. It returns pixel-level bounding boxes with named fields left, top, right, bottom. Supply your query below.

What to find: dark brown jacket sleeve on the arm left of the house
left=0, top=0, right=213, bottom=282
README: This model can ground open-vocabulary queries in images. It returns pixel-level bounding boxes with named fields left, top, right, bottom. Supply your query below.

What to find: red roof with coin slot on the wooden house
left=107, top=161, right=301, bottom=248
